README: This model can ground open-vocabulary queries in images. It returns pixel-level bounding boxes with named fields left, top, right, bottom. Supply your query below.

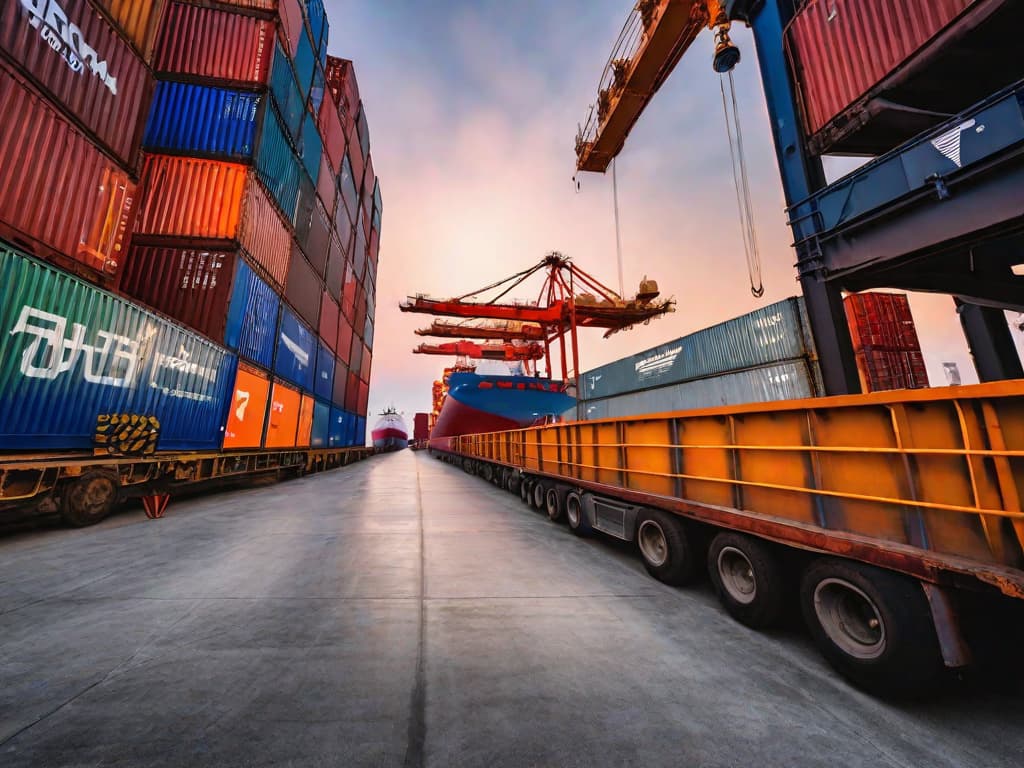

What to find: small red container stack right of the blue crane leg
left=845, top=293, right=928, bottom=392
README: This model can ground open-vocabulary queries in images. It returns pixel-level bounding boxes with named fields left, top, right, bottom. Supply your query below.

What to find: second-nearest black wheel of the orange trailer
left=708, top=531, right=786, bottom=630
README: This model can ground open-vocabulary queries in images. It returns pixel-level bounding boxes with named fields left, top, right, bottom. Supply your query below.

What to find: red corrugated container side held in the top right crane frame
left=786, top=0, right=976, bottom=134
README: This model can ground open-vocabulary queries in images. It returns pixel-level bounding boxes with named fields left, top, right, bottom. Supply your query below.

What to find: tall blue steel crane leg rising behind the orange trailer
left=741, top=0, right=860, bottom=395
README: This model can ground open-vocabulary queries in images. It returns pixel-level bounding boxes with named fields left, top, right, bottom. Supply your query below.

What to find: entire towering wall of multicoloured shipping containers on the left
left=0, top=0, right=381, bottom=450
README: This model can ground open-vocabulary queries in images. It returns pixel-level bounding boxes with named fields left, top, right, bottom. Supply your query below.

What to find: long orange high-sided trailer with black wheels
left=430, top=381, right=1024, bottom=692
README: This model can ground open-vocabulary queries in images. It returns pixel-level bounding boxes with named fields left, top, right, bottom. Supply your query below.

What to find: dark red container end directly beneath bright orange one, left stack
left=120, top=246, right=235, bottom=342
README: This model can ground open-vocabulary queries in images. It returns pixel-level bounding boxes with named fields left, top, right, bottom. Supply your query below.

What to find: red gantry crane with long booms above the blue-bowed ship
left=399, top=252, right=675, bottom=382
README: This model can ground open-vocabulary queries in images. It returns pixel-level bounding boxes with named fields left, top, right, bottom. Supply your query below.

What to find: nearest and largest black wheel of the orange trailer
left=800, top=557, right=943, bottom=696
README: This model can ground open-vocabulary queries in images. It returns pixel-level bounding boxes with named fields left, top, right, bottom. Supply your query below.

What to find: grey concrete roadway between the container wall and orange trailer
left=0, top=452, right=1024, bottom=768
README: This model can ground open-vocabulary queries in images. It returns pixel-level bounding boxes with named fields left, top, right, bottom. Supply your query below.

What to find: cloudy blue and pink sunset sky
left=326, top=0, right=1024, bottom=426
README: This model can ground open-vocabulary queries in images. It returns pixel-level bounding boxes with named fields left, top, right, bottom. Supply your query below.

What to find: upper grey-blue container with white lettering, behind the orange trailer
left=581, top=298, right=815, bottom=399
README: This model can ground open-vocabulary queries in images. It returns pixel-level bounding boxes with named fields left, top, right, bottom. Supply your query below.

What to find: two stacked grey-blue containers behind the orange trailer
left=577, top=298, right=823, bottom=419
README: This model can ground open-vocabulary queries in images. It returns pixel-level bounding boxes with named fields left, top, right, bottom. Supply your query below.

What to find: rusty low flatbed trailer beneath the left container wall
left=0, top=446, right=374, bottom=526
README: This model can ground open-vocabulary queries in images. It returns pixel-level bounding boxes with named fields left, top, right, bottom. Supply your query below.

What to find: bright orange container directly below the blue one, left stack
left=136, top=155, right=292, bottom=288
